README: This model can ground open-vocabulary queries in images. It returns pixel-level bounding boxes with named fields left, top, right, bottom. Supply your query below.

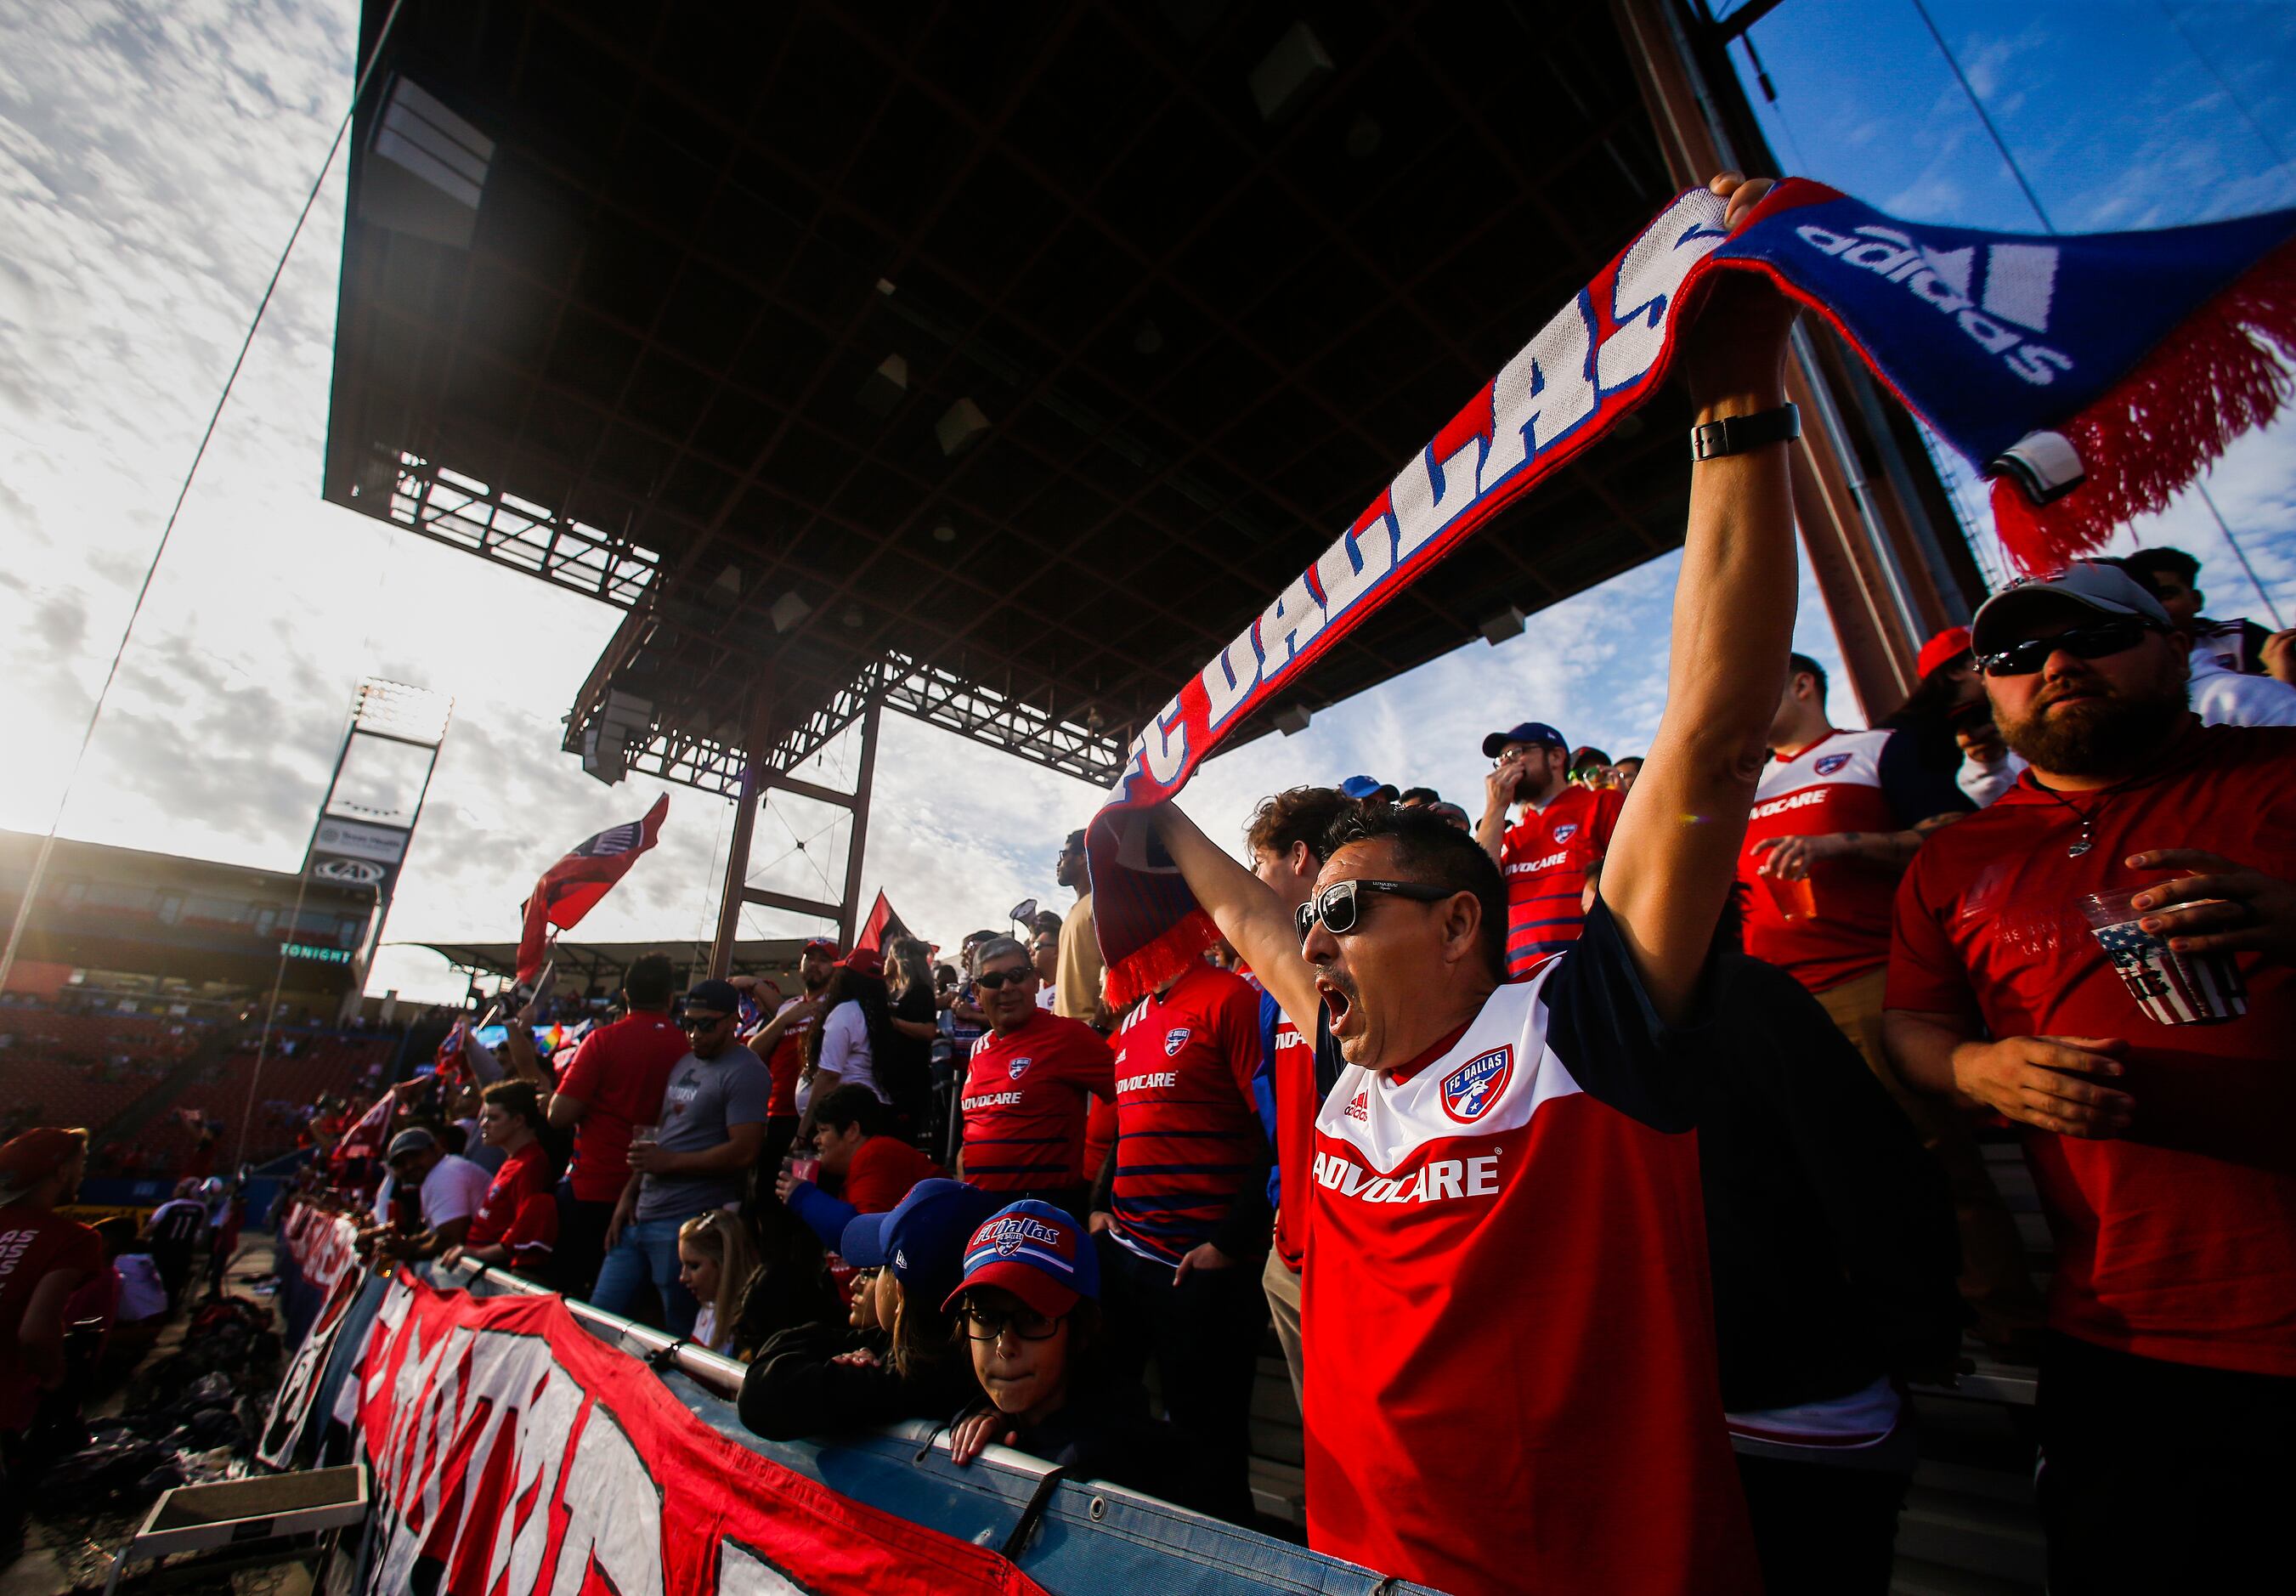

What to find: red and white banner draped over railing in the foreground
left=328, top=1272, right=1043, bottom=1596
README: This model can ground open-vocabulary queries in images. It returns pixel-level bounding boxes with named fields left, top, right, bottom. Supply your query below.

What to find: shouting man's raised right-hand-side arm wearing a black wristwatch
left=1603, top=173, right=1796, bottom=1020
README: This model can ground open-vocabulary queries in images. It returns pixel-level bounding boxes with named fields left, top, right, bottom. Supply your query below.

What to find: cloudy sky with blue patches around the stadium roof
left=0, top=0, right=2296, bottom=997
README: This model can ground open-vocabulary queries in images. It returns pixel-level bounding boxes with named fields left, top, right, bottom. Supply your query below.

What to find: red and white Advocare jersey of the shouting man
left=1283, top=905, right=1759, bottom=1596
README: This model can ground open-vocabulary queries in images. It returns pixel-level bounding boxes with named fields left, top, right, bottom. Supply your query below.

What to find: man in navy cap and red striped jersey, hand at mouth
left=1474, top=721, right=1626, bottom=976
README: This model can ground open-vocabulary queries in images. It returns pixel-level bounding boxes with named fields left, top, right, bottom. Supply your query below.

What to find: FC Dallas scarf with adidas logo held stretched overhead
left=1089, top=179, right=2296, bottom=1006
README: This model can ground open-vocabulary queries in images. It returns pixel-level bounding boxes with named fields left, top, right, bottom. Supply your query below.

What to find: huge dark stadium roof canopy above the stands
left=324, top=0, right=1763, bottom=792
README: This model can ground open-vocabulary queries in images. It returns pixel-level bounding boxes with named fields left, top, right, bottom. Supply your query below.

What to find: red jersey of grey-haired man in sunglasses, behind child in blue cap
left=959, top=1008, right=1116, bottom=1191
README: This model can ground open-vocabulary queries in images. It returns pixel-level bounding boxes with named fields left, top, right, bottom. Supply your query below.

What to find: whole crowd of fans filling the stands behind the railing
left=0, top=194, right=2296, bottom=1592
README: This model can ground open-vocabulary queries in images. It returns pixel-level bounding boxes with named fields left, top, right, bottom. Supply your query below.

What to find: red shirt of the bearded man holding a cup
left=1887, top=726, right=2296, bottom=1378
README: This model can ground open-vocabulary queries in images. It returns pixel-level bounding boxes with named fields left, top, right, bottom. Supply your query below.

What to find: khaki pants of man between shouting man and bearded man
left=1816, top=969, right=2041, bottom=1344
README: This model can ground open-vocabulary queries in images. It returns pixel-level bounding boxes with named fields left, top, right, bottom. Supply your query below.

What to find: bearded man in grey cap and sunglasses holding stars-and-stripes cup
left=1885, top=563, right=2296, bottom=1596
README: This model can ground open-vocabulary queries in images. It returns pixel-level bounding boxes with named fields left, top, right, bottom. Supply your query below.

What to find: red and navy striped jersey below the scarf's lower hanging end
left=1111, top=965, right=1268, bottom=1263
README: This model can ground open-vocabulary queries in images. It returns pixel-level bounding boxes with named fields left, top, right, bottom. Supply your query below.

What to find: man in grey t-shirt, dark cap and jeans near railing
left=590, top=981, right=774, bottom=1337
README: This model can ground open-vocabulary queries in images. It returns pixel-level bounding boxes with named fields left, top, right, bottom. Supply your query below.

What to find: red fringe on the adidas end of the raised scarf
left=1993, top=241, right=2296, bottom=572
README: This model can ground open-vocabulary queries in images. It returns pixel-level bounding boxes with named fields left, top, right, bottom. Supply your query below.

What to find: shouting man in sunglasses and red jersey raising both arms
left=1151, top=174, right=1796, bottom=1596
